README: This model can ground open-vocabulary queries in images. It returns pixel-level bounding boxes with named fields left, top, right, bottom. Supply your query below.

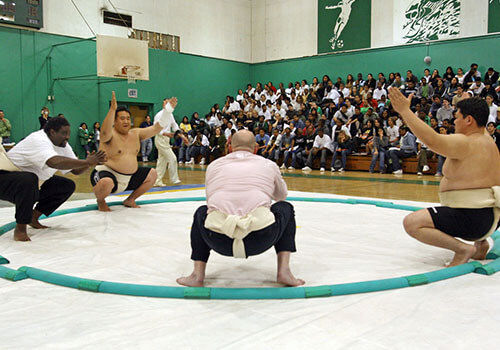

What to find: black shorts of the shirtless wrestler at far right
left=427, top=207, right=499, bottom=241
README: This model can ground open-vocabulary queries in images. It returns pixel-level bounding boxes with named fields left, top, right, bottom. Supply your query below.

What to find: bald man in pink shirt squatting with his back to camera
left=177, top=130, right=305, bottom=287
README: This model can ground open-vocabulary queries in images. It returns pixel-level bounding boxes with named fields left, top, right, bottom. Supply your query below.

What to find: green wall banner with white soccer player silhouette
left=318, top=0, right=372, bottom=53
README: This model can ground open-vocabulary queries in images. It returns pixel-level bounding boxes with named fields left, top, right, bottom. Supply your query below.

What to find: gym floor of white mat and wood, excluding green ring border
left=0, top=166, right=500, bottom=349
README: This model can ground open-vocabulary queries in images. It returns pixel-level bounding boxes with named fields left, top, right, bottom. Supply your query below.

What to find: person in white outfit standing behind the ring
left=154, top=99, right=184, bottom=187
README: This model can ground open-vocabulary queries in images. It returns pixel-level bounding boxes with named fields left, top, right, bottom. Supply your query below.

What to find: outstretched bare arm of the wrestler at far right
left=389, top=87, right=470, bottom=159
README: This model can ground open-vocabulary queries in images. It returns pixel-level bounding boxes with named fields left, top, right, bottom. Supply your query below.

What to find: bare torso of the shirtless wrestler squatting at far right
left=439, top=133, right=500, bottom=192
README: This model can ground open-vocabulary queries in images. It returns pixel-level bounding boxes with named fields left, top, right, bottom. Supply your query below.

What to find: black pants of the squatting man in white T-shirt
left=0, top=170, right=75, bottom=224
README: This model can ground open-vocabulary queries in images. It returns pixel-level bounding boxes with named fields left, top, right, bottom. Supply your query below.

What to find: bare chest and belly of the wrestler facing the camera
left=99, top=129, right=141, bottom=174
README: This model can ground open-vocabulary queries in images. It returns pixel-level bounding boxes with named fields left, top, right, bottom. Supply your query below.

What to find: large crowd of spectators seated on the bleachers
left=174, top=64, right=500, bottom=176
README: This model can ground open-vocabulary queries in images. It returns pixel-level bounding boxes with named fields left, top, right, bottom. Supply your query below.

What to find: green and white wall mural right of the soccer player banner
left=403, top=0, right=460, bottom=43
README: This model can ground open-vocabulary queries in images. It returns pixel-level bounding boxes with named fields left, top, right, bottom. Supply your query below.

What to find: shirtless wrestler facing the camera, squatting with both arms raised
left=90, top=91, right=177, bottom=211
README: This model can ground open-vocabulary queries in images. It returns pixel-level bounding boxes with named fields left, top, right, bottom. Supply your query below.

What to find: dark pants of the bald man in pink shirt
left=191, top=202, right=296, bottom=262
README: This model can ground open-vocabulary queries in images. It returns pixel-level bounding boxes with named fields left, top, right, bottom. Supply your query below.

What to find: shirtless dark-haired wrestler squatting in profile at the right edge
left=389, top=88, right=500, bottom=266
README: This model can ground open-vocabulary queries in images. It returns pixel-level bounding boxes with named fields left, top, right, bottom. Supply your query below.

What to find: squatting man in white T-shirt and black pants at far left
left=0, top=117, right=106, bottom=241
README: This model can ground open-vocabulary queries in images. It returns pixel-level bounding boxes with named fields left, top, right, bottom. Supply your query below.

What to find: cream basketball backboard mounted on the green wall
left=96, top=35, right=149, bottom=82
